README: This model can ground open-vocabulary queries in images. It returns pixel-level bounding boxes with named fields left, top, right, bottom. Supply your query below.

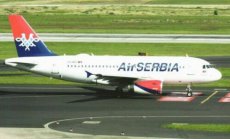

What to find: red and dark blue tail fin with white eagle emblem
left=9, top=15, right=55, bottom=57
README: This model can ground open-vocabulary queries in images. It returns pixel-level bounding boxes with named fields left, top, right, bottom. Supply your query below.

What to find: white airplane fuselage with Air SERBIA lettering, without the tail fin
left=5, top=54, right=221, bottom=84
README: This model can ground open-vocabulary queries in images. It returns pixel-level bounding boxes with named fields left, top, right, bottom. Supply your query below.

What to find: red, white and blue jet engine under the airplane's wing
left=128, top=80, right=162, bottom=94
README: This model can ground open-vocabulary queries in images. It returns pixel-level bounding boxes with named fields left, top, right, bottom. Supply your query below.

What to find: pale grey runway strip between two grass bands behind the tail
left=0, top=33, right=230, bottom=44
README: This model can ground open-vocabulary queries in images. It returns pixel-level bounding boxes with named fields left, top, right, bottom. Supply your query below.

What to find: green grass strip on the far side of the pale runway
left=0, top=12, right=230, bottom=34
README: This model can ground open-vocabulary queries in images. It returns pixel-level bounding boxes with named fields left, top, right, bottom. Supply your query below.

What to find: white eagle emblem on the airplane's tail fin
left=15, top=33, right=39, bottom=51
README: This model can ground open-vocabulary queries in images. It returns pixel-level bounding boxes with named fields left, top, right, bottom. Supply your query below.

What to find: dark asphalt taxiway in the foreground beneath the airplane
left=0, top=85, right=230, bottom=139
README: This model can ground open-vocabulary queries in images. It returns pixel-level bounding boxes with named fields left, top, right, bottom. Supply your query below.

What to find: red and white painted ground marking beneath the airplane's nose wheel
left=158, top=96, right=195, bottom=102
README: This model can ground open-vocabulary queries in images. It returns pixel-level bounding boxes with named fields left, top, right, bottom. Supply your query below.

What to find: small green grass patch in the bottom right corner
left=162, top=123, right=230, bottom=133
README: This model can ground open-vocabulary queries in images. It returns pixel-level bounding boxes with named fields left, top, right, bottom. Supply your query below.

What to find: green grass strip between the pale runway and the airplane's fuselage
left=0, top=42, right=230, bottom=60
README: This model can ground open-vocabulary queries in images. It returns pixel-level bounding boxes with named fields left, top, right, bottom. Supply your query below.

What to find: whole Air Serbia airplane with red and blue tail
left=5, top=14, right=222, bottom=97
